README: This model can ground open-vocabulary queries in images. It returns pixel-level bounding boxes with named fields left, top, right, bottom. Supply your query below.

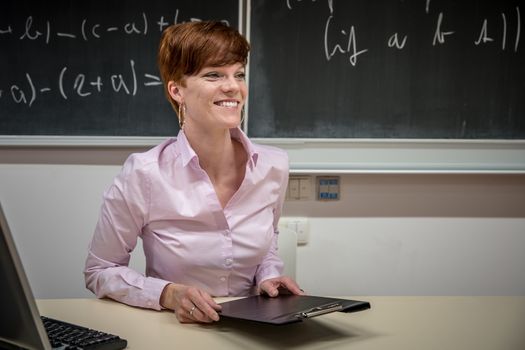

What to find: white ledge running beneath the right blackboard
left=252, top=138, right=525, bottom=174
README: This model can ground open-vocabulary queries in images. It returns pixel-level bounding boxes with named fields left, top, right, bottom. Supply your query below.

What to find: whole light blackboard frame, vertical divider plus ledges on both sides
left=0, top=0, right=525, bottom=174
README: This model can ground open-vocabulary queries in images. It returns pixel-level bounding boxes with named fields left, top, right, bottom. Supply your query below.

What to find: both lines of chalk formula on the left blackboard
left=0, top=9, right=228, bottom=107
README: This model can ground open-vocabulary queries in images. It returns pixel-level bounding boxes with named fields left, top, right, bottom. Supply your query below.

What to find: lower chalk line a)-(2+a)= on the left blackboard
left=0, top=59, right=162, bottom=108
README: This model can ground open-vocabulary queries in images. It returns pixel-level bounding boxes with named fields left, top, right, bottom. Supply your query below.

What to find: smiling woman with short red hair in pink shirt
left=84, top=22, right=302, bottom=322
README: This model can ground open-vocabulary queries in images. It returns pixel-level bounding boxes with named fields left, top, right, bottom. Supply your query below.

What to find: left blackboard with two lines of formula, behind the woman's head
left=0, top=0, right=239, bottom=136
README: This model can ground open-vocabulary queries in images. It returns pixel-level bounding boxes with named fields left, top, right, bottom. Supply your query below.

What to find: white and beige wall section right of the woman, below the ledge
left=285, top=175, right=525, bottom=295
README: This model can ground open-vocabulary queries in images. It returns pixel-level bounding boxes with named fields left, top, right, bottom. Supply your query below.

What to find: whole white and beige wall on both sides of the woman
left=0, top=147, right=525, bottom=298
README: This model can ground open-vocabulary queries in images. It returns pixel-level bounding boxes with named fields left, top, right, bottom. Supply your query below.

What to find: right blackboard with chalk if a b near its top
left=248, top=0, right=525, bottom=140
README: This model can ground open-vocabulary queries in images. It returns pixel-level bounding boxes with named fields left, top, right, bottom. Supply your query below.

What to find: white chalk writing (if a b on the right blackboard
left=285, top=0, right=521, bottom=66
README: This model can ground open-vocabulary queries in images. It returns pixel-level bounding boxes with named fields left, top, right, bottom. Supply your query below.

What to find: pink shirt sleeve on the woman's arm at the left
left=84, top=156, right=169, bottom=310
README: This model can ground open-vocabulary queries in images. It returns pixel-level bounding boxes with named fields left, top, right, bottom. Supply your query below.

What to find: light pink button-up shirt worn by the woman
left=84, top=129, right=288, bottom=309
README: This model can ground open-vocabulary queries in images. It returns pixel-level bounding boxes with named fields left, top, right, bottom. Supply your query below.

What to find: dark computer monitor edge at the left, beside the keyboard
left=0, top=205, right=51, bottom=350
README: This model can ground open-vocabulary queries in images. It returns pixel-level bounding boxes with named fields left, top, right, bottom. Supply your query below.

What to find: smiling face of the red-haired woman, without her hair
left=168, top=63, right=248, bottom=131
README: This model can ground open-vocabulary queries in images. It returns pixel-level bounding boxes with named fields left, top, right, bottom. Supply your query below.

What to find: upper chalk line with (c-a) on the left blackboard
left=0, top=9, right=229, bottom=44
